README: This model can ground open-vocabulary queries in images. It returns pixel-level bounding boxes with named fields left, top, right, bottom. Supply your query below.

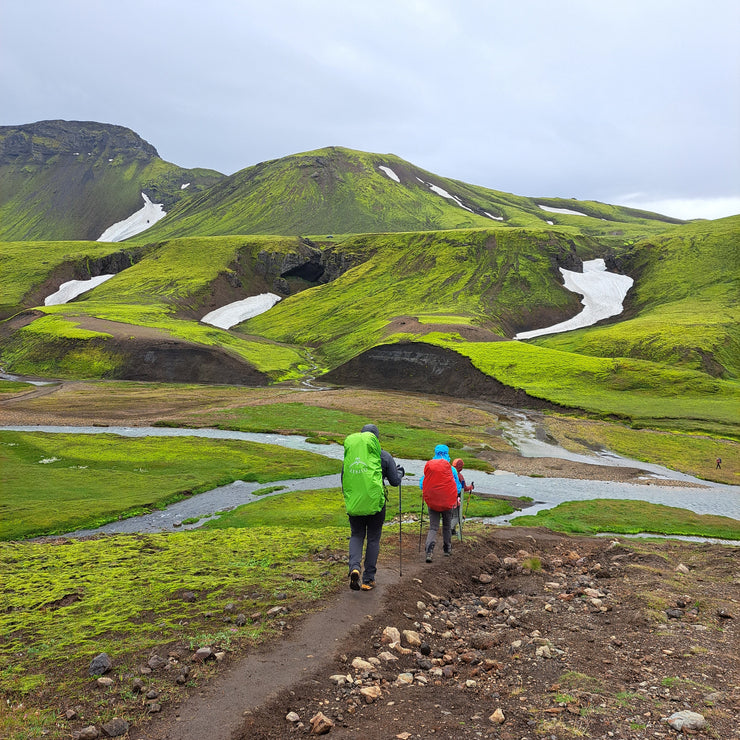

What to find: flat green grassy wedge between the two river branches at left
left=0, top=432, right=337, bottom=540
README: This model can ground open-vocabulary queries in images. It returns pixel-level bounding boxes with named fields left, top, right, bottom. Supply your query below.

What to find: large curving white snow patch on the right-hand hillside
left=514, top=258, right=635, bottom=339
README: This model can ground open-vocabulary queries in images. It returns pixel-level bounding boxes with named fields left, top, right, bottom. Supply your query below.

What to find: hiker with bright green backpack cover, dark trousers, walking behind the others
left=341, top=424, right=404, bottom=591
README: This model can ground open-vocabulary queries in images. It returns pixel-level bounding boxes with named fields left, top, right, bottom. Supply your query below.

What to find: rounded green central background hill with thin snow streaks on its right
left=134, top=147, right=684, bottom=238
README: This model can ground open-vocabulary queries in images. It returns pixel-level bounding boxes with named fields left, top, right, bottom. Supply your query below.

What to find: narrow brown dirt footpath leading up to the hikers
left=141, top=551, right=421, bottom=740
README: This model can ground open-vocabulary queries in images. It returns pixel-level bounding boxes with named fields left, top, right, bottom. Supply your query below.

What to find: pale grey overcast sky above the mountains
left=0, top=0, right=740, bottom=218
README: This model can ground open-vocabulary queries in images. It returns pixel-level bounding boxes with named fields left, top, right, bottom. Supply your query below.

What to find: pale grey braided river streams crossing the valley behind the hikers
left=0, top=424, right=740, bottom=536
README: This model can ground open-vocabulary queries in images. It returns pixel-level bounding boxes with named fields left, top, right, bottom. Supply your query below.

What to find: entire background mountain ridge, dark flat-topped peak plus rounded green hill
left=0, top=121, right=681, bottom=240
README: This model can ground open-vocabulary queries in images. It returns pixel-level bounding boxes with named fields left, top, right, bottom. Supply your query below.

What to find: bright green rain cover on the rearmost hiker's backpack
left=342, top=432, right=385, bottom=516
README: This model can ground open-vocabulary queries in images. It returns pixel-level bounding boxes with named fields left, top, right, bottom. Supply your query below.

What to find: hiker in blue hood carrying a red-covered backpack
left=419, top=445, right=462, bottom=563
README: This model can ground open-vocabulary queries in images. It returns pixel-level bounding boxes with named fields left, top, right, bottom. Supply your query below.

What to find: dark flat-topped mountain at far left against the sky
left=0, top=121, right=223, bottom=240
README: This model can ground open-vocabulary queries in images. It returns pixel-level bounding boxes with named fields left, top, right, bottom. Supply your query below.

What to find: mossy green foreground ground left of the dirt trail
left=0, top=527, right=347, bottom=738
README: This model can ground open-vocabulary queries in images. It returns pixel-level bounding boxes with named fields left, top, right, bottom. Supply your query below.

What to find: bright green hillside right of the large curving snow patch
left=533, top=216, right=740, bottom=378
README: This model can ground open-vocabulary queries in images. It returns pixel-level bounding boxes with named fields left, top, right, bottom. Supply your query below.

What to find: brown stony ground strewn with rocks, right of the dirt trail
left=234, top=529, right=740, bottom=740
